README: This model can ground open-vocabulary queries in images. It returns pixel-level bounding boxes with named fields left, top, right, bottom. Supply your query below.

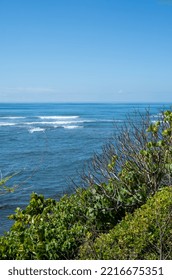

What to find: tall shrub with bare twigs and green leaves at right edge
left=86, top=111, right=172, bottom=212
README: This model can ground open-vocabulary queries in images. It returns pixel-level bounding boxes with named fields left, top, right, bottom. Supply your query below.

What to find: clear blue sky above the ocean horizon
left=0, top=0, right=172, bottom=103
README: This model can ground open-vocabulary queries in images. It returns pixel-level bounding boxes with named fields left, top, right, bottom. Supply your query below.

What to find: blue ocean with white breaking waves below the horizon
left=0, top=103, right=170, bottom=234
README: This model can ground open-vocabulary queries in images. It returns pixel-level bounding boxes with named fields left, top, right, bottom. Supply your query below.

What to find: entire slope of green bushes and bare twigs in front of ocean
left=0, top=111, right=172, bottom=260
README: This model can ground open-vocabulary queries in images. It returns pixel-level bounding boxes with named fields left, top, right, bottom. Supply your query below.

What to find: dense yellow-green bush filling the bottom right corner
left=80, top=187, right=172, bottom=260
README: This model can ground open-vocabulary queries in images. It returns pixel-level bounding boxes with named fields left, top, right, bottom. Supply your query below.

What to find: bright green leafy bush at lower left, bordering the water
left=0, top=186, right=121, bottom=259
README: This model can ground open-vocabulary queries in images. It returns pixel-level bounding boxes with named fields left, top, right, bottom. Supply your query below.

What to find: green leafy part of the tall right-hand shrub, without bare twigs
left=112, top=111, right=172, bottom=209
